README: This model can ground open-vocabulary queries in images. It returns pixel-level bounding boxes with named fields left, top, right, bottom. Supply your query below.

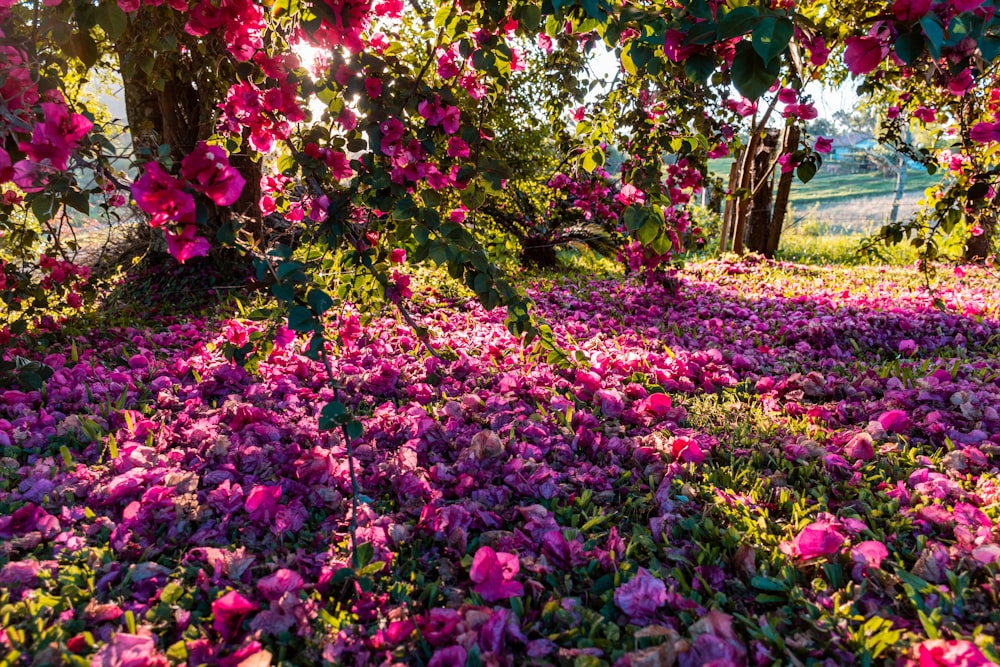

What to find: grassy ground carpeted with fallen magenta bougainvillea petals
left=0, top=262, right=1000, bottom=667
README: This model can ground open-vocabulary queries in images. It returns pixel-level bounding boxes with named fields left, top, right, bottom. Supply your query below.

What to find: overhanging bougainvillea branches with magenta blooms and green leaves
left=0, top=0, right=998, bottom=330
